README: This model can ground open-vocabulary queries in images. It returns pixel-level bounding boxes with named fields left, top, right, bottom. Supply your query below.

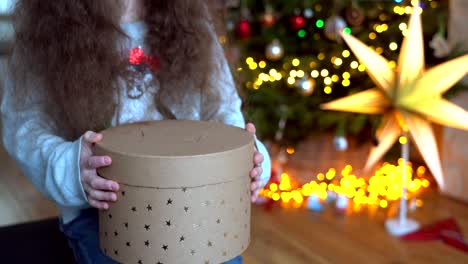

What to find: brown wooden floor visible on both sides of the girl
left=0, top=143, right=468, bottom=264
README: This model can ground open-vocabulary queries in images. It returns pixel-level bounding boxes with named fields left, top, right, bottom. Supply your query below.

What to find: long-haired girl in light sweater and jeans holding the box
left=1, top=0, right=270, bottom=264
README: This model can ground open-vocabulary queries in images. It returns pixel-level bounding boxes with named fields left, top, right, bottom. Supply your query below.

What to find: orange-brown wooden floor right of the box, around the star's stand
left=244, top=195, right=468, bottom=264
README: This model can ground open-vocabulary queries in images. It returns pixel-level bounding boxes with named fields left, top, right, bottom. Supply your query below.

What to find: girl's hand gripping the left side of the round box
left=80, top=131, right=119, bottom=210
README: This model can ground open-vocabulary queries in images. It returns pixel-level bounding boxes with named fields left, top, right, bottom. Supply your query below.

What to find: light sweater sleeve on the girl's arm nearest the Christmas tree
left=213, top=37, right=271, bottom=190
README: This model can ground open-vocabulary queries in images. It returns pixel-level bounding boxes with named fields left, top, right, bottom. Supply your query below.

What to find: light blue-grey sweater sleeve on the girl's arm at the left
left=1, top=71, right=87, bottom=207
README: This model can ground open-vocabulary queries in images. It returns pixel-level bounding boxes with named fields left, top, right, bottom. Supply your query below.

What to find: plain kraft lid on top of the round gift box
left=94, top=120, right=254, bottom=188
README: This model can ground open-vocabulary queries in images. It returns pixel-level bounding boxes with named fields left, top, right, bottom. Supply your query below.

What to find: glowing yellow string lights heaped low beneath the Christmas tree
left=260, top=162, right=430, bottom=208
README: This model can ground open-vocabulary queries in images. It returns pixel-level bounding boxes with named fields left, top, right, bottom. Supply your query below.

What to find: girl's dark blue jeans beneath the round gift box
left=60, top=208, right=242, bottom=264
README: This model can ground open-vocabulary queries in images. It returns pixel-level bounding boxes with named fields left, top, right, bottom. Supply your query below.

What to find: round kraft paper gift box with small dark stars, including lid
left=94, top=121, right=254, bottom=264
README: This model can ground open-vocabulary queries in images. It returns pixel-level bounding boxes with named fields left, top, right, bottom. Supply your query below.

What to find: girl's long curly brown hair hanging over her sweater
left=10, top=0, right=225, bottom=140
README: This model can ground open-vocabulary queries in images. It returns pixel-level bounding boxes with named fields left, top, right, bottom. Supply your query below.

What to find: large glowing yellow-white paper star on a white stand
left=321, top=7, right=468, bottom=188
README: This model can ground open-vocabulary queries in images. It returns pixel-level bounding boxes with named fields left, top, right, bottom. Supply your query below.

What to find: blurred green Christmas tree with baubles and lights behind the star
left=224, top=0, right=456, bottom=146
